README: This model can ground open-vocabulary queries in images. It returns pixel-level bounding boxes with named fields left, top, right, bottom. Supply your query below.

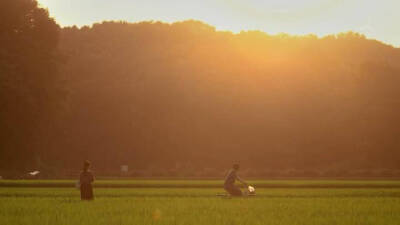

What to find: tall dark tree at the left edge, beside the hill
left=0, top=0, right=60, bottom=170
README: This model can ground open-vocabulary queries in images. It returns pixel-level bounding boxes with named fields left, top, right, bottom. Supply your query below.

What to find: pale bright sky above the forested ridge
left=38, top=0, right=400, bottom=47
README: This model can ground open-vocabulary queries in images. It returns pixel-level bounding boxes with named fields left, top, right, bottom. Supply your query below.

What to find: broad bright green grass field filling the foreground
left=0, top=185, right=400, bottom=225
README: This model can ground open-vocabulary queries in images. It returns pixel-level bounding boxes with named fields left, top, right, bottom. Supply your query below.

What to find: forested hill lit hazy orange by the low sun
left=5, top=11, right=400, bottom=176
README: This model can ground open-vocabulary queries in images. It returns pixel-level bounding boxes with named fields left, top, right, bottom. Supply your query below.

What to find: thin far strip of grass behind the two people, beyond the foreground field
left=0, top=180, right=400, bottom=188
